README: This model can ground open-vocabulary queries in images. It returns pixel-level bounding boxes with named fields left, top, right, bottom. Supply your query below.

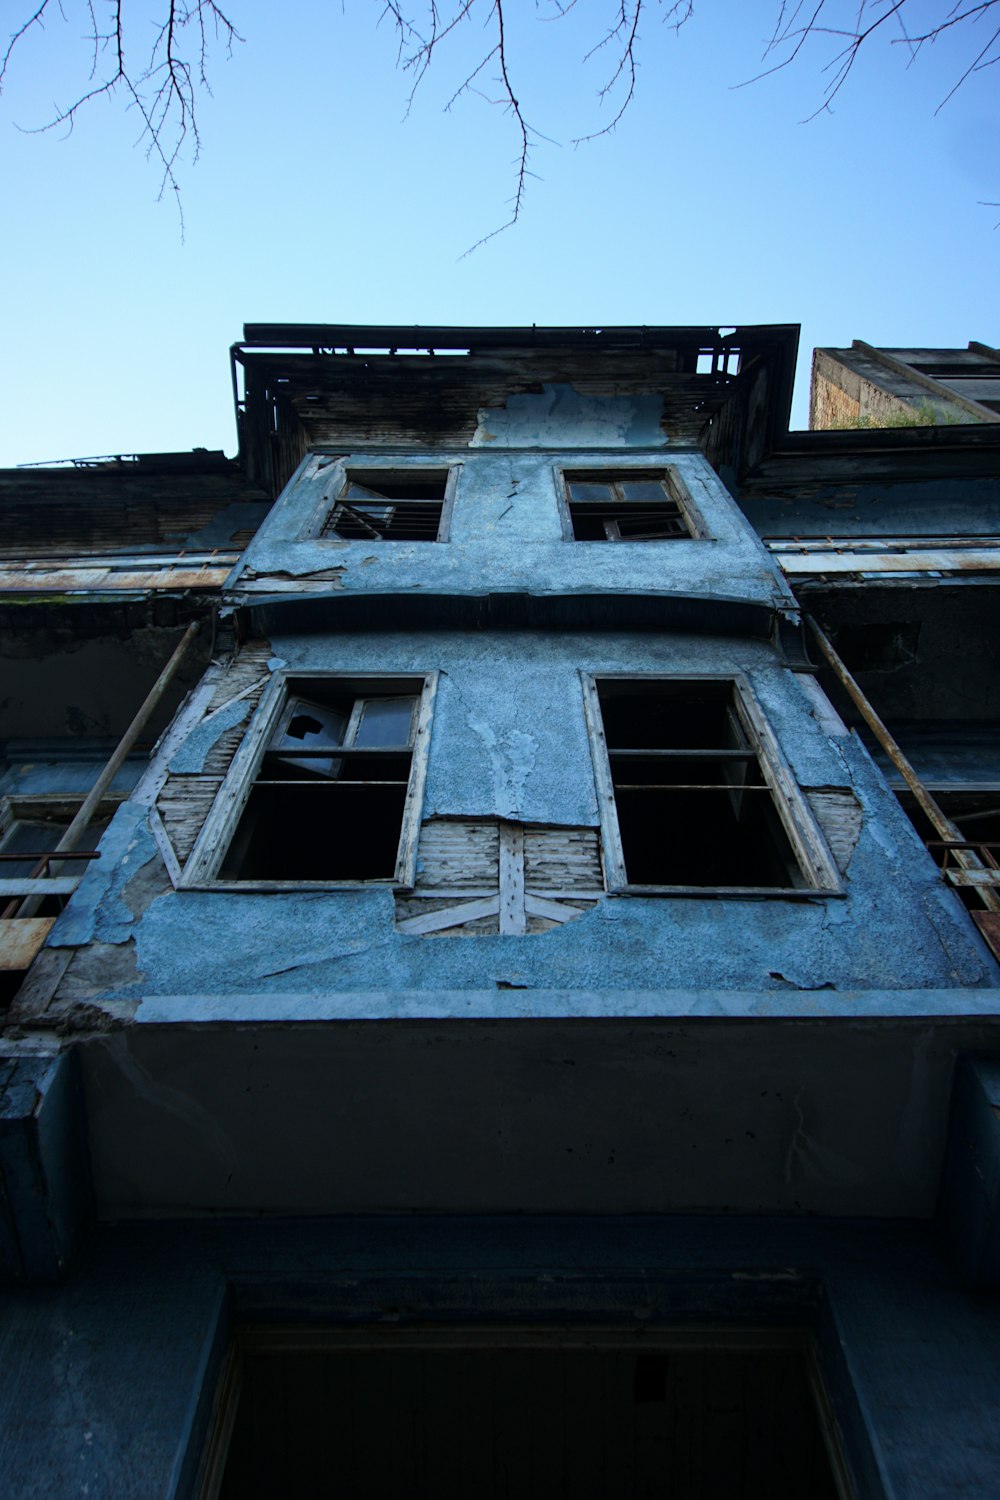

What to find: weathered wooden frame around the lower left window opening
left=180, top=671, right=438, bottom=891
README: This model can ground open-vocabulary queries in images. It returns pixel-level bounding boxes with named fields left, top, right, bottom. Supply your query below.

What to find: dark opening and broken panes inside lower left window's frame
left=219, top=680, right=423, bottom=881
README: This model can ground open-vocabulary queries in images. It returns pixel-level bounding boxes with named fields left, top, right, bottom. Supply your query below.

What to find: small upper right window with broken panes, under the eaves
left=564, top=470, right=703, bottom=542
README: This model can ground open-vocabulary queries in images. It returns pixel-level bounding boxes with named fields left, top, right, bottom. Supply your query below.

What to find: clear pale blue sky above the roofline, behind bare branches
left=0, top=0, right=1000, bottom=465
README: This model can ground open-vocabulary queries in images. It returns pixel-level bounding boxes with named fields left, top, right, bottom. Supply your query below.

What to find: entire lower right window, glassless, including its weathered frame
left=588, top=678, right=838, bottom=894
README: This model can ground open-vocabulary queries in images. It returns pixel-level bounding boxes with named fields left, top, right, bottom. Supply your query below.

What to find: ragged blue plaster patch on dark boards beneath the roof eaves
left=469, top=384, right=667, bottom=449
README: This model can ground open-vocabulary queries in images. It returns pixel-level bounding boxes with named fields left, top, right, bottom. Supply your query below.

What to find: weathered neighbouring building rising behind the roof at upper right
left=810, top=339, right=1000, bottom=429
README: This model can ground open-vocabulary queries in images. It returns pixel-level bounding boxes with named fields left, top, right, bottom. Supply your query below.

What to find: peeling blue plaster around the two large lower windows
left=51, top=632, right=999, bottom=1017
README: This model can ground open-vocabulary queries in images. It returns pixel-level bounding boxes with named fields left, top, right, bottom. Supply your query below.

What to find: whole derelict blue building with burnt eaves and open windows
left=0, top=326, right=1000, bottom=1500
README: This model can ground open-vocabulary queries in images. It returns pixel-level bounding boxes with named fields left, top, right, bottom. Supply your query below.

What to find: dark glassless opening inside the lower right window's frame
left=598, top=681, right=805, bottom=888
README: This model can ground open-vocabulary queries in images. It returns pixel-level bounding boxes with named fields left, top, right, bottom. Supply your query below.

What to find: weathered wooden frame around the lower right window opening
left=580, top=672, right=846, bottom=900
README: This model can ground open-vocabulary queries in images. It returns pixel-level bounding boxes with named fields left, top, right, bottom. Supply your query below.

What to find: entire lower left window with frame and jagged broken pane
left=193, top=677, right=429, bottom=885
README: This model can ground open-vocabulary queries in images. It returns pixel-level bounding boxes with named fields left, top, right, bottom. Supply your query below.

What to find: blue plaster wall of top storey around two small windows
left=228, top=449, right=790, bottom=605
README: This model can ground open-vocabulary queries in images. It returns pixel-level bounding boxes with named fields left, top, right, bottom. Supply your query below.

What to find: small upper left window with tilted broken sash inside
left=319, top=468, right=448, bottom=542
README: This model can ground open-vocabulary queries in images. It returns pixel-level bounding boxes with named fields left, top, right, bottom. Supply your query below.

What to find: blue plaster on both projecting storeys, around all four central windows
left=35, top=438, right=1000, bottom=1014
